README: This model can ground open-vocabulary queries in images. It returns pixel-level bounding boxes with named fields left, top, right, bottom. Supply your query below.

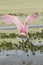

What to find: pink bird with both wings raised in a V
left=2, top=13, right=38, bottom=36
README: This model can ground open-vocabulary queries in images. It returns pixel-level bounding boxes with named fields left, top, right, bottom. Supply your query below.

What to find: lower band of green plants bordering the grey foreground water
left=0, top=40, right=43, bottom=54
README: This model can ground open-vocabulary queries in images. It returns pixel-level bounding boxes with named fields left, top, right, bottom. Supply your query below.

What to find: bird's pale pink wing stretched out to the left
left=1, top=14, right=23, bottom=33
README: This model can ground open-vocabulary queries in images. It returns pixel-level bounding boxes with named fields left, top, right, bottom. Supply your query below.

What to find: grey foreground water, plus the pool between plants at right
left=0, top=37, right=43, bottom=65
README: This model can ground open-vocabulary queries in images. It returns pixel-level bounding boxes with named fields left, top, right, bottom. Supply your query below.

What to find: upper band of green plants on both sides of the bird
left=0, top=30, right=43, bottom=39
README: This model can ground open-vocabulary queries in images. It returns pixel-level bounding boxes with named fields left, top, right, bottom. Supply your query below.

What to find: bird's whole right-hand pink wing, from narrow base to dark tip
left=24, top=13, right=38, bottom=34
